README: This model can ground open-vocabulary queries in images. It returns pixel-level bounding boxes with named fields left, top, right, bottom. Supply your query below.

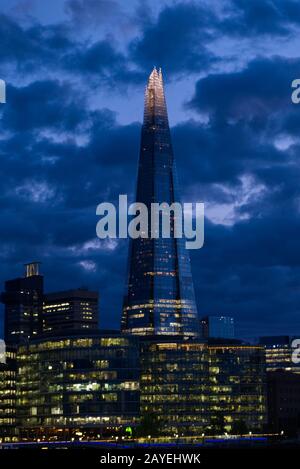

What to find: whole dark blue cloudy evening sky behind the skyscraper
left=0, top=0, right=300, bottom=337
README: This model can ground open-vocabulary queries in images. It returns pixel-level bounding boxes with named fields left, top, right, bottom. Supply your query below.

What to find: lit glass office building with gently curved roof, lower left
left=17, top=333, right=139, bottom=438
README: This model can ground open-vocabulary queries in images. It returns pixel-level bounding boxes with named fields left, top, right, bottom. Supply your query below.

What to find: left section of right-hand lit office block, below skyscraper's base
left=141, top=337, right=209, bottom=437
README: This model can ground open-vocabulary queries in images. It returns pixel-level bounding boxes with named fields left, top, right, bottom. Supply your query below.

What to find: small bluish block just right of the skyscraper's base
left=201, top=316, right=234, bottom=339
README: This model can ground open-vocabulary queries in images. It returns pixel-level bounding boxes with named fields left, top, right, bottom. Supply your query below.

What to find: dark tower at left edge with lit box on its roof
left=1, top=262, right=44, bottom=344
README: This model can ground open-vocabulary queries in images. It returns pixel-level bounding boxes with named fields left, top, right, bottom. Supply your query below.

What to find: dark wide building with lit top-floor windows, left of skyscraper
left=42, top=288, right=99, bottom=334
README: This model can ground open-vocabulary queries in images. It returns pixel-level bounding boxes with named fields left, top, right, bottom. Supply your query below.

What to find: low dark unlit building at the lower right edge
left=267, top=370, right=300, bottom=436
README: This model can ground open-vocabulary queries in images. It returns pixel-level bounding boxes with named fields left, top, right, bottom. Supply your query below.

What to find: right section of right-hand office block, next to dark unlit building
left=208, top=345, right=267, bottom=433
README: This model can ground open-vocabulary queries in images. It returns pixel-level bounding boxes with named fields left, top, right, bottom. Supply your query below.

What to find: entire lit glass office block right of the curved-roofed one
left=141, top=339, right=266, bottom=436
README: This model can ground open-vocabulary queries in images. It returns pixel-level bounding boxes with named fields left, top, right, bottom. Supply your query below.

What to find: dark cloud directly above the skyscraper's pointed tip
left=130, top=2, right=216, bottom=75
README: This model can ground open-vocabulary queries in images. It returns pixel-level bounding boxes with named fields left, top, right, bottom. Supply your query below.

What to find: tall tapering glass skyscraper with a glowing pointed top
left=122, top=68, right=199, bottom=336
